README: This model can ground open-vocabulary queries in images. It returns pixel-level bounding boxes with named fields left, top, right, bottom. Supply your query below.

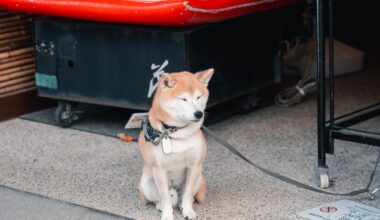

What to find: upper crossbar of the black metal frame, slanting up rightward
left=335, top=105, right=380, bottom=128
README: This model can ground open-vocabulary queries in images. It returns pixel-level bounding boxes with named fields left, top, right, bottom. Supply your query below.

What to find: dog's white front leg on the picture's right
left=180, top=165, right=202, bottom=220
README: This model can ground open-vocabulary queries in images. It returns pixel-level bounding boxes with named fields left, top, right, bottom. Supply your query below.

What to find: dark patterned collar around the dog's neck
left=141, top=119, right=186, bottom=145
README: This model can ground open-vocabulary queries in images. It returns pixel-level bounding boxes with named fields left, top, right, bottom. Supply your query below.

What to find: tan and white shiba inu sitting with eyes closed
left=138, top=69, right=214, bottom=220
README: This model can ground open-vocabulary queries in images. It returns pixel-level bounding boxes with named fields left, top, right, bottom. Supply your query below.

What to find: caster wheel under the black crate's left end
left=54, top=102, right=79, bottom=128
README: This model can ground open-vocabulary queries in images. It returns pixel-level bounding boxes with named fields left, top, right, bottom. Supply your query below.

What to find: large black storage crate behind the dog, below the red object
left=34, top=9, right=281, bottom=110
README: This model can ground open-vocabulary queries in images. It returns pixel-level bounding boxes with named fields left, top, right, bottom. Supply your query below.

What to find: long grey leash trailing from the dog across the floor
left=202, top=125, right=380, bottom=199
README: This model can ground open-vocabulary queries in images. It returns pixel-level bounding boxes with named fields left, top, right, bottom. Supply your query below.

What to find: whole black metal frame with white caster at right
left=316, top=0, right=380, bottom=188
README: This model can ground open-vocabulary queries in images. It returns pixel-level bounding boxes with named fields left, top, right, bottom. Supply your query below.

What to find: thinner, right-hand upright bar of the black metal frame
left=327, top=0, right=335, bottom=154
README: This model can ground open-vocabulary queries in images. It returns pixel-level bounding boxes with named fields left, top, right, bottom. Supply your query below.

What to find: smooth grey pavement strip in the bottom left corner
left=0, top=186, right=128, bottom=220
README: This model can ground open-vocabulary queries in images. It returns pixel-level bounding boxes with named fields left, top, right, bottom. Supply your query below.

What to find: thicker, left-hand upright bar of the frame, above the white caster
left=316, top=0, right=326, bottom=166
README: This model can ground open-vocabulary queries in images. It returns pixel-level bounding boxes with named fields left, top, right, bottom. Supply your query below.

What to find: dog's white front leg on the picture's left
left=152, top=167, right=174, bottom=220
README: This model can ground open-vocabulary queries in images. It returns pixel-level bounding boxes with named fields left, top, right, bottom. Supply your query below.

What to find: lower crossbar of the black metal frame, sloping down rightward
left=330, top=126, right=380, bottom=147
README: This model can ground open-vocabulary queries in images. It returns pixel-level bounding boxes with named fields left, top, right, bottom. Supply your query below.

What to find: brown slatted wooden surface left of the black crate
left=0, top=9, right=49, bottom=121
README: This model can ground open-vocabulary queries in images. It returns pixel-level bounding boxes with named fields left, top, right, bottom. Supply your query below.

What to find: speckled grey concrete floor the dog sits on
left=0, top=65, right=380, bottom=219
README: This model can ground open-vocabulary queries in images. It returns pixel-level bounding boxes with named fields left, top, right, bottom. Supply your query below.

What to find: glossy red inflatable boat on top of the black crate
left=0, top=0, right=297, bottom=26
